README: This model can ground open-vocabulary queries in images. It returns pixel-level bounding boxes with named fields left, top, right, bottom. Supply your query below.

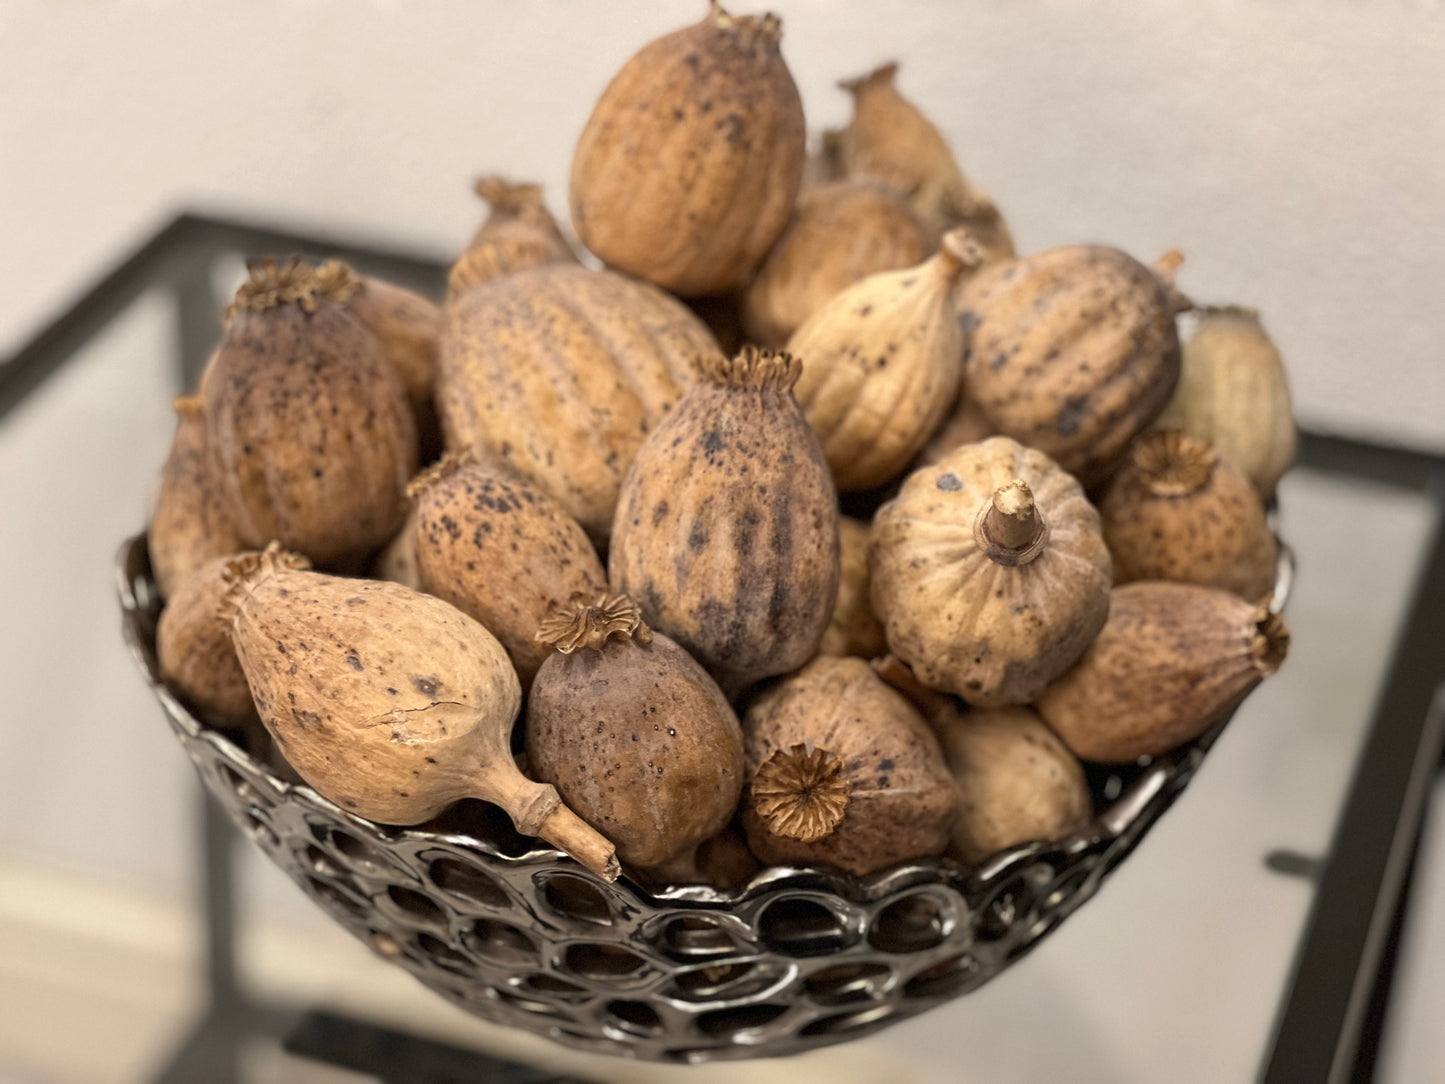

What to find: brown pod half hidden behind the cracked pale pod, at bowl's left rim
left=156, top=554, right=311, bottom=727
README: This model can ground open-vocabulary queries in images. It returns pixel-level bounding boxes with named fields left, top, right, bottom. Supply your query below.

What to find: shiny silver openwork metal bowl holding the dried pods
left=117, top=536, right=1293, bottom=1064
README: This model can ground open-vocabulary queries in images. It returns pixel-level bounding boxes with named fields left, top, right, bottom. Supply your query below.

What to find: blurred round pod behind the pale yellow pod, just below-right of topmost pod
left=743, top=181, right=932, bottom=347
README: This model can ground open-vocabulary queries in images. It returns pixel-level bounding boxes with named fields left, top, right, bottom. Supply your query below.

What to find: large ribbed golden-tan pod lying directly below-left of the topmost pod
left=438, top=263, right=723, bottom=542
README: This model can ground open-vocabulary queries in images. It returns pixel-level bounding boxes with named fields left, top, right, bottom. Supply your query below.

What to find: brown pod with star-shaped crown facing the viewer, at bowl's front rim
left=743, top=658, right=957, bottom=876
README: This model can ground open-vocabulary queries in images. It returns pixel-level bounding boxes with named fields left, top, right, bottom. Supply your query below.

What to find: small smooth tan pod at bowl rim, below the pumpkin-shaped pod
left=931, top=707, right=1094, bottom=866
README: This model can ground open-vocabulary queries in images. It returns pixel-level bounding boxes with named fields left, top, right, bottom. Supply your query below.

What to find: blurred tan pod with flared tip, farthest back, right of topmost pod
left=838, top=64, right=1013, bottom=263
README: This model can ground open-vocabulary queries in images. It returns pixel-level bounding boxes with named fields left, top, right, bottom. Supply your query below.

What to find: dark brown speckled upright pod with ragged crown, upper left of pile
left=205, top=260, right=418, bottom=568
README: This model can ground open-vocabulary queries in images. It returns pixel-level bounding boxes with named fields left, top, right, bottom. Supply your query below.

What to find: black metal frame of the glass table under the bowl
left=0, top=214, right=1445, bottom=1084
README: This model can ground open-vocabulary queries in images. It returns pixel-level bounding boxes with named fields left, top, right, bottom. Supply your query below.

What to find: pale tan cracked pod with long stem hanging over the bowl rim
left=221, top=548, right=617, bottom=880
